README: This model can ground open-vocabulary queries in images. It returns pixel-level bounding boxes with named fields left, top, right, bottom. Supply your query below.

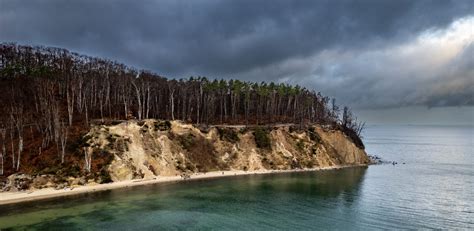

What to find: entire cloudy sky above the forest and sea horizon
left=0, top=0, right=474, bottom=125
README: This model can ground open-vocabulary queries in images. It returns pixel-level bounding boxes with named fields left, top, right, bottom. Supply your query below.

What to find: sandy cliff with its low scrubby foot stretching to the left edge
left=0, top=120, right=370, bottom=192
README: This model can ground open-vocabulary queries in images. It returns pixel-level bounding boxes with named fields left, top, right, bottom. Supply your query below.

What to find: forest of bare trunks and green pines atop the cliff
left=0, top=43, right=363, bottom=176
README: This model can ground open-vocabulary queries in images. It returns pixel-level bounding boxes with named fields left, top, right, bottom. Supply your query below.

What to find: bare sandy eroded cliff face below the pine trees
left=80, top=120, right=369, bottom=181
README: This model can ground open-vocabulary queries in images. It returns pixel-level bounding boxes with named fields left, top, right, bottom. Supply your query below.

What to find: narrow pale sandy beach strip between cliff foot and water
left=0, top=165, right=368, bottom=206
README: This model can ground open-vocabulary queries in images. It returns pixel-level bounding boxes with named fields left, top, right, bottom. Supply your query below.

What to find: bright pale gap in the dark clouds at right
left=250, top=17, right=474, bottom=112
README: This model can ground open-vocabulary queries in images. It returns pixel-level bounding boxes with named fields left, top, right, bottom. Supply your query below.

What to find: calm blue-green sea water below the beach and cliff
left=0, top=126, right=474, bottom=230
